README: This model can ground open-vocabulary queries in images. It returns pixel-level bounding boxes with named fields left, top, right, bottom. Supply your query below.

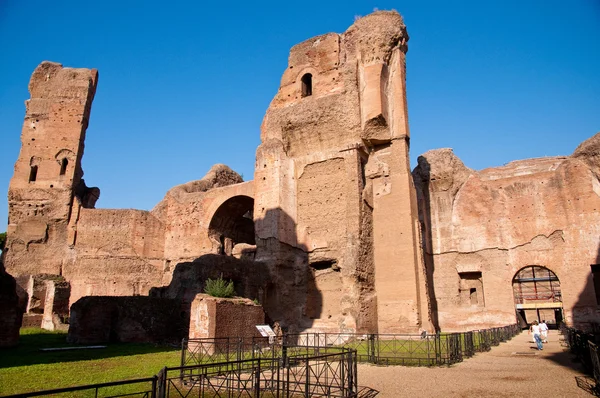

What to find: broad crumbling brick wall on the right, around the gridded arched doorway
left=413, top=135, right=600, bottom=330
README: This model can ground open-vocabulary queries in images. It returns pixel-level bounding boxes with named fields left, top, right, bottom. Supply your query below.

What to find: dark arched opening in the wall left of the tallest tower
left=208, top=195, right=256, bottom=255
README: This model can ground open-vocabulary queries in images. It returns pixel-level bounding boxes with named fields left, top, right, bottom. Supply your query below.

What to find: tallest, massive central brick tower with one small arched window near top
left=254, top=11, right=431, bottom=332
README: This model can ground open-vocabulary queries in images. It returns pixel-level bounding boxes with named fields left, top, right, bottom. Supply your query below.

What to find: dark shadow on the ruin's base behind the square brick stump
left=149, top=209, right=323, bottom=332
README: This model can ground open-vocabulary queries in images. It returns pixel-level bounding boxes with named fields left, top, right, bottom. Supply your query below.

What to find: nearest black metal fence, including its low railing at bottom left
left=7, top=346, right=358, bottom=398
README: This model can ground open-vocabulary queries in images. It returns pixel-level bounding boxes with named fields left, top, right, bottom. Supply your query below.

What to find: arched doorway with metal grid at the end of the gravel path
left=512, top=265, right=563, bottom=327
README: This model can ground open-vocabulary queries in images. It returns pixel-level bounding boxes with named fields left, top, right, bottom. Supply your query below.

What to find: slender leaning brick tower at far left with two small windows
left=5, top=62, right=100, bottom=276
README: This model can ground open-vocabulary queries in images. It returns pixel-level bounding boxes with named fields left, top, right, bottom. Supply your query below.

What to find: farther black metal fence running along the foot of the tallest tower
left=181, top=325, right=520, bottom=366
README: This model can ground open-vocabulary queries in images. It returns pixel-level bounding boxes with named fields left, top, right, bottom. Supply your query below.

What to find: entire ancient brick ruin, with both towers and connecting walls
left=5, top=11, right=600, bottom=346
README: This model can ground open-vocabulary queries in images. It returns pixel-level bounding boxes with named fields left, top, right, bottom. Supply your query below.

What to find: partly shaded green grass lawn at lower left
left=0, top=328, right=181, bottom=395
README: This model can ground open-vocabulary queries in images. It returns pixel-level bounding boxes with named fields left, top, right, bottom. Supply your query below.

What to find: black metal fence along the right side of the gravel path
left=561, top=325, right=600, bottom=395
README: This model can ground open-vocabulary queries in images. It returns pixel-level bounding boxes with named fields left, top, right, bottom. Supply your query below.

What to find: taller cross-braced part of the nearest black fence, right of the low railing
left=166, top=346, right=358, bottom=398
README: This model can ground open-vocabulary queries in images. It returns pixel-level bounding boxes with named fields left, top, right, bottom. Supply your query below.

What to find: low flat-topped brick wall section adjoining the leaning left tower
left=64, top=209, right=164, bottom=303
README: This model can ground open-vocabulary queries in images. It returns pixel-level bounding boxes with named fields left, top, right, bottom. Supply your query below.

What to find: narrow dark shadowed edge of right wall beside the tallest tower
left=412, top=156, right=440, bottom=331
